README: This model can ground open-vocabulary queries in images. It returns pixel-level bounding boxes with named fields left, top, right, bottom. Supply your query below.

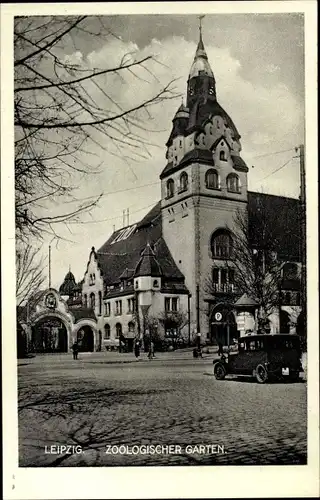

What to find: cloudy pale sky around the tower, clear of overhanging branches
left=16, top=13, right=304, bottom=288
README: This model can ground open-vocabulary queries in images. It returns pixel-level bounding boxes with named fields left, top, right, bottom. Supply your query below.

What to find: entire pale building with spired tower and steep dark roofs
left=17, top=29, right=301, bottom=350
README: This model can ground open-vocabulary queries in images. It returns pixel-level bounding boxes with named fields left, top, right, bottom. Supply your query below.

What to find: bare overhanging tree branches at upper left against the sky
left=14, top=16, right=178, bottom=240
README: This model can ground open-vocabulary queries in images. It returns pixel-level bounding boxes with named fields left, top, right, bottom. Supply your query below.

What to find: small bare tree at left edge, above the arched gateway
left=16, top=243, right=46, bottom=306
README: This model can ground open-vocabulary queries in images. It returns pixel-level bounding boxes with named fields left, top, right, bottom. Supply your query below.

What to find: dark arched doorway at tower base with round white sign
left=210, top=307, right=239, bottom=345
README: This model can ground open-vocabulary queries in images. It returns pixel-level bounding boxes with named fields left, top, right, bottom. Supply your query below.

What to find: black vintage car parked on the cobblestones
left=213, top=334, right=303, bottom=384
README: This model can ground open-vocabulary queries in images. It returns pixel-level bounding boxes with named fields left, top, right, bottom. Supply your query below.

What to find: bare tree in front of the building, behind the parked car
left=205, top=207, right=282, bottom=331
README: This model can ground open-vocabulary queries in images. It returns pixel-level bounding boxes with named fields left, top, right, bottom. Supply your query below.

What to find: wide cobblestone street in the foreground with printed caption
left=18, top=352, right=307, bottom=467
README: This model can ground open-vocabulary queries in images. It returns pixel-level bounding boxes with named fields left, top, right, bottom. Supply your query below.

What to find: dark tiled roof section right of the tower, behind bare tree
left=248, top=191, right=300, bottom=262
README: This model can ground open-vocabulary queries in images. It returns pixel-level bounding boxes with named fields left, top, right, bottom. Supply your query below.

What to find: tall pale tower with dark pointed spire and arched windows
left=160, top=21, right=248, bottom=338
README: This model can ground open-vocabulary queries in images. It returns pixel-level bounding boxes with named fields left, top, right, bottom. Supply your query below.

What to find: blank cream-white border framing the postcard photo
left=1, top=1, right=319, bottom=500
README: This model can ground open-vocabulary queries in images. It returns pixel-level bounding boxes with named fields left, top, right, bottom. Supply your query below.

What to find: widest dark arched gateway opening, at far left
left=32, top=316, right=68, bottom=353
